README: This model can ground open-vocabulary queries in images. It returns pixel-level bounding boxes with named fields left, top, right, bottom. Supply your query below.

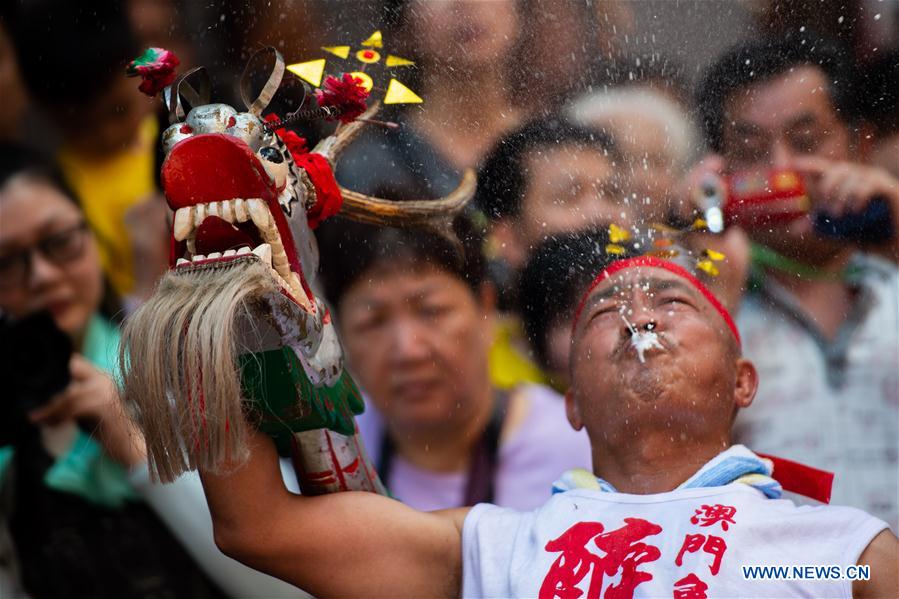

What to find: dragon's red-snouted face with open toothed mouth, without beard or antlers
left=162, top=104, right=318, bottom=312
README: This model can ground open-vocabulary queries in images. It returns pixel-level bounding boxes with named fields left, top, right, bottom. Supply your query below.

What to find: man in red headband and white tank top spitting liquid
left=202, top=257, right=899, bottom=598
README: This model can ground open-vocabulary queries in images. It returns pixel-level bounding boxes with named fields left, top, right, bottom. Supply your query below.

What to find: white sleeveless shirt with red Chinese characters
left=462, top=483, right=887, bottom=599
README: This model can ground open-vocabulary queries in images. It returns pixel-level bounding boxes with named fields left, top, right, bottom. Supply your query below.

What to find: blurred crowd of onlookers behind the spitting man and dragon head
left=0, top=0, right=899, bottom=597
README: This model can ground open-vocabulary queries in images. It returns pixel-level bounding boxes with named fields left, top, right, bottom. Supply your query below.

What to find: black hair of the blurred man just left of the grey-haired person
left=474, top=117, right=617, bottom=219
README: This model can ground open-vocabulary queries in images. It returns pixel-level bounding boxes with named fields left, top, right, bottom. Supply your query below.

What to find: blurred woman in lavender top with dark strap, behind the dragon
left=319, top=217, right=591, bottom=510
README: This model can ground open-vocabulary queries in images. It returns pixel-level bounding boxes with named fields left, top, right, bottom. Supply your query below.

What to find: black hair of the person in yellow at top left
left=7, top=0, right=140, bottom=108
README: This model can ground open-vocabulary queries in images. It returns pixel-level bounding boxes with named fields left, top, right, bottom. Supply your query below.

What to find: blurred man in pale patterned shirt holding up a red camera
left=693, top=33, right=899, bottom=529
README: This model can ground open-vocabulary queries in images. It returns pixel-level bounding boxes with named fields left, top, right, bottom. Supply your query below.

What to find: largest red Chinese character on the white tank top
left=540, top=518, right=662, bottom=599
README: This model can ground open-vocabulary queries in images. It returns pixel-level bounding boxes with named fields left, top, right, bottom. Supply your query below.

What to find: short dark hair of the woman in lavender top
left=316, top=214, right=486, bottom=308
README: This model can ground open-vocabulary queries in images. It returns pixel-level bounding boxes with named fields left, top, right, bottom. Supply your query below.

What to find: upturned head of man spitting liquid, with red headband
left=566, top=257, right=757, bottom=452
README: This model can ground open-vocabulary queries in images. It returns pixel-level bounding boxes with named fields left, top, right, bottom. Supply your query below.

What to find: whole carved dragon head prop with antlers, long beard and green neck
left=122, top=48, right=474, bottom=494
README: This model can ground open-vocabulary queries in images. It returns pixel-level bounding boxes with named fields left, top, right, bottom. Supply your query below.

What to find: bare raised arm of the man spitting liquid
left=201, top=432, right=466, bottom=597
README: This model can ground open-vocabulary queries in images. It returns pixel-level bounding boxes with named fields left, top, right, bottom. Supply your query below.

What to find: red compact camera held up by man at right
left=723, top=169, right=810, bottom=229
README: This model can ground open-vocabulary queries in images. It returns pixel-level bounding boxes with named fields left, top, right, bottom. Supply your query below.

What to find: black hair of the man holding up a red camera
left=696, top=31, right=857, bottom=152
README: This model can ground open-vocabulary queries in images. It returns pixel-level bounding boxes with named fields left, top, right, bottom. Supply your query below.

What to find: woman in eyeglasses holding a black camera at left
left=0, top=145, right=300, bottom=598
